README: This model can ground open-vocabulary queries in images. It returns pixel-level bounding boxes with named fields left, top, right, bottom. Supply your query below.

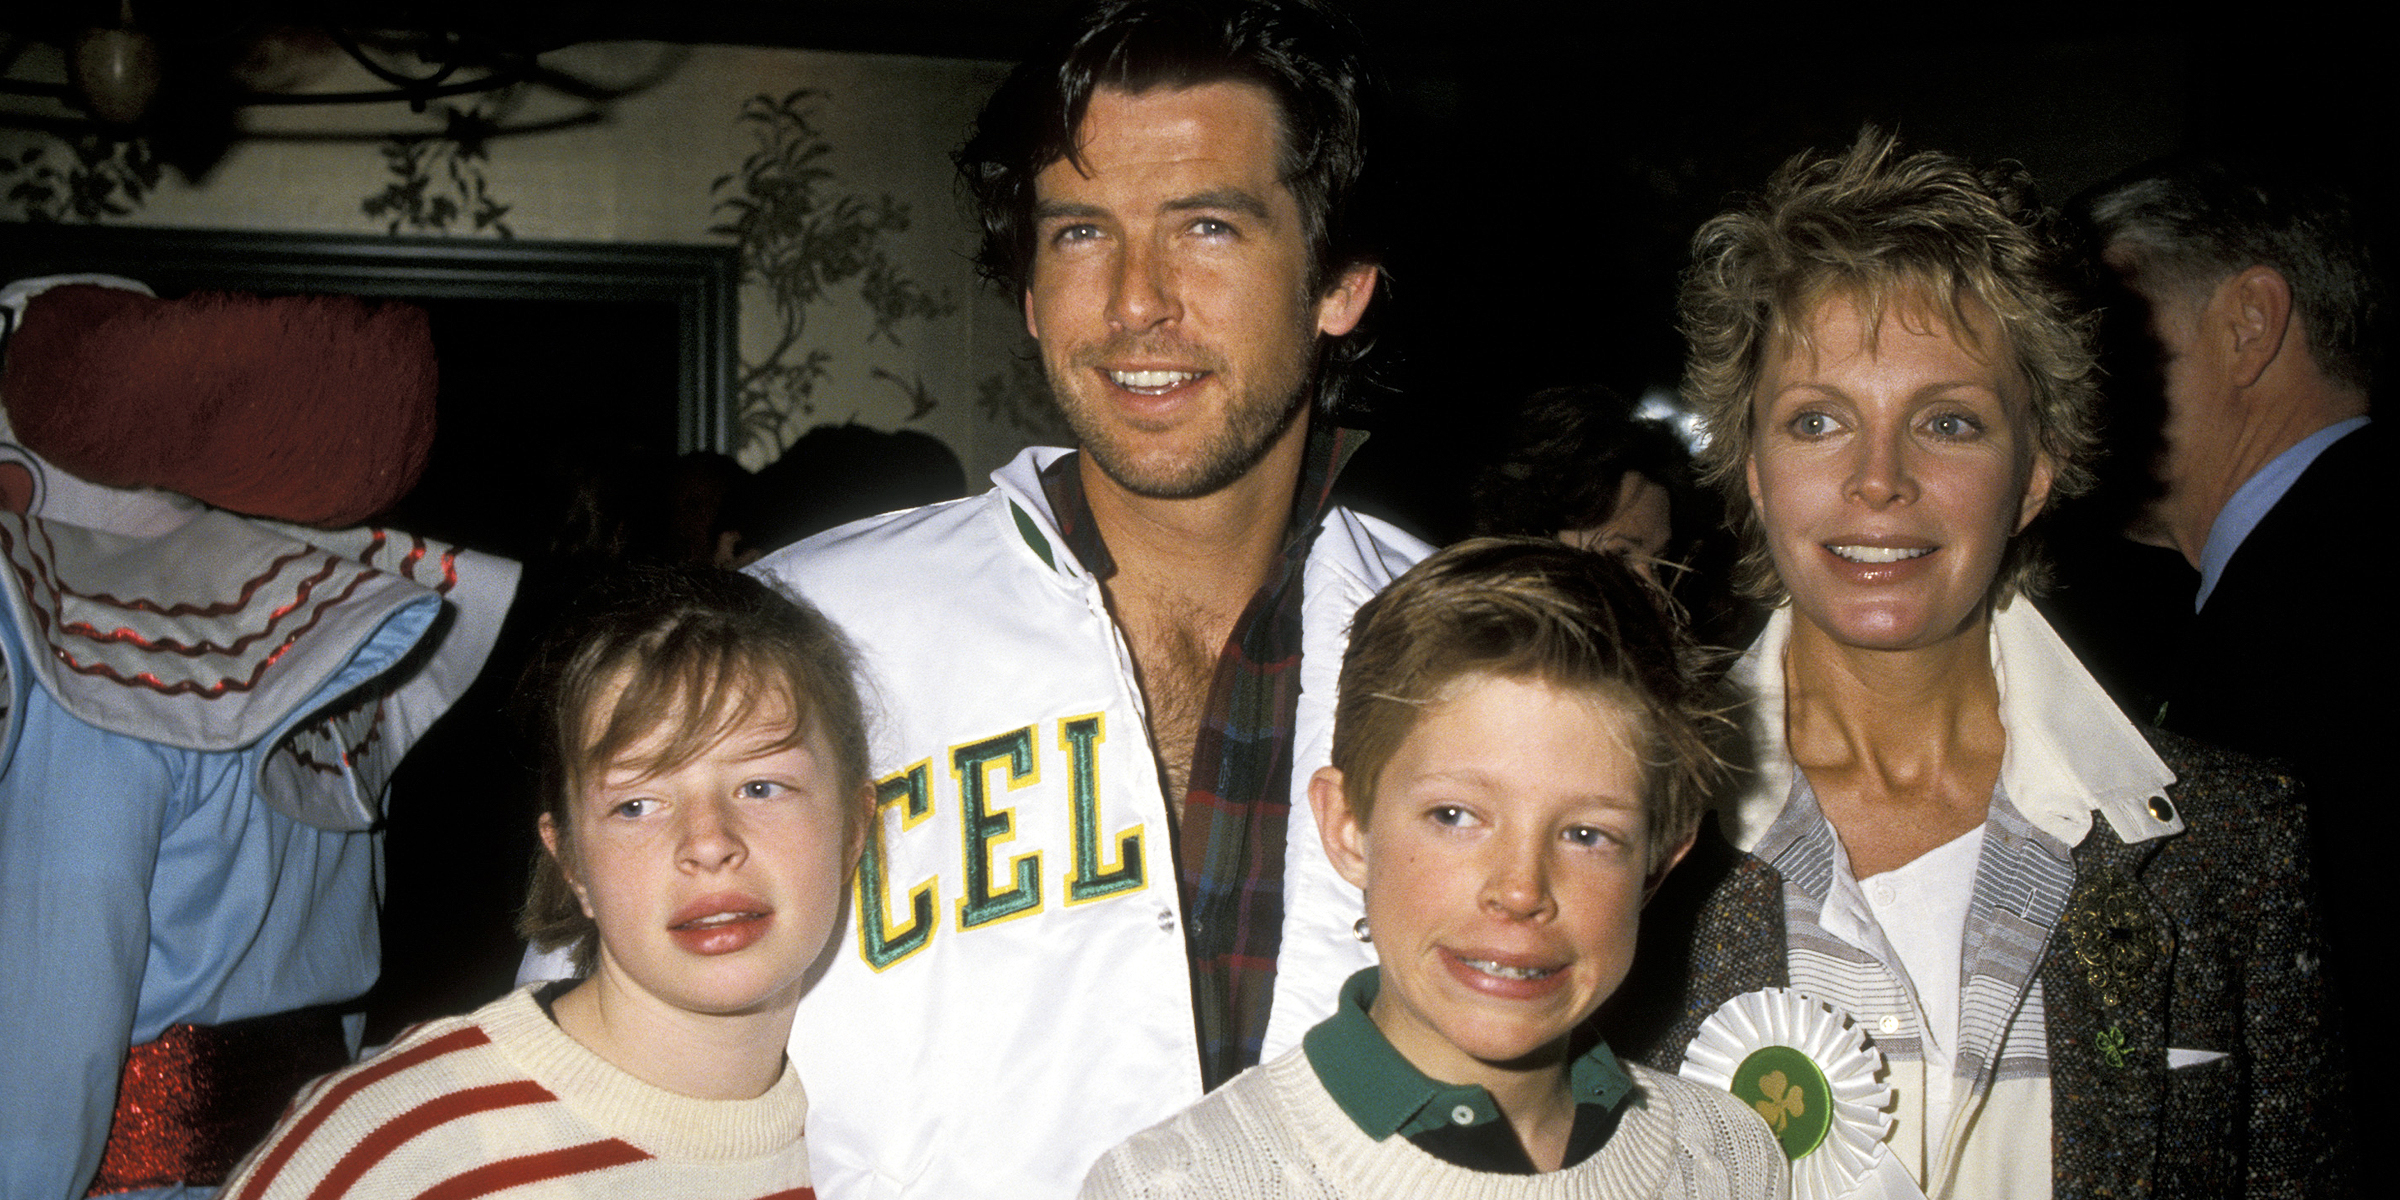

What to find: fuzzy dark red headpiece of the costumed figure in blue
left=0, top=283, right=434, bottom=528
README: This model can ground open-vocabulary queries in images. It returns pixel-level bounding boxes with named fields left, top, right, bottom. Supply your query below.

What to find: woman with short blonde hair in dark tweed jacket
left=1622, top=132, right=2345, bottom=1198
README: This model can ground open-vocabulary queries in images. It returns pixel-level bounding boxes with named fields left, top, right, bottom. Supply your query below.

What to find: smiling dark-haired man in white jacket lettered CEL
left=758, top=0, right=1426, bottom=1198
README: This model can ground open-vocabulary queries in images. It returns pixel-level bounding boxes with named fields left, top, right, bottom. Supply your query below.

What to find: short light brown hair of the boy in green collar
left=1332, top=538, right=1733, bottom=874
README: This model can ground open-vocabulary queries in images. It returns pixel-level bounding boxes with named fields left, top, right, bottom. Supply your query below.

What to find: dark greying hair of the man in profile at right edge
left=2076, top=156, right=2381, bottom=391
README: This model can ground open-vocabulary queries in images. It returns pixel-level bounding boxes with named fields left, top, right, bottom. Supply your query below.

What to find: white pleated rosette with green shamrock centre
left=1682, top=986, right=1891, bottom=1200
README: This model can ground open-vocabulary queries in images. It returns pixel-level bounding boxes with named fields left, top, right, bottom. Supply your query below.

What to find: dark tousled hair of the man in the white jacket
left=955, top=0, right=1380, bottom=403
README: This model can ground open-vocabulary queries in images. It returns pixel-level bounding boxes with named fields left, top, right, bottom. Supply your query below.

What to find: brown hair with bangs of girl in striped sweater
left=516, top=566, right=871, bottom=972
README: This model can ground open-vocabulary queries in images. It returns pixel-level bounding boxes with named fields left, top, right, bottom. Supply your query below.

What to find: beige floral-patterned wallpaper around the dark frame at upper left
left=0, top=43, right=1058, bottom=480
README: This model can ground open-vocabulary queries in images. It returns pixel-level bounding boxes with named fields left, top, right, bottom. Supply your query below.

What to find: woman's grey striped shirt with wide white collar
left=1718, top=602, right=2184, bottom=1200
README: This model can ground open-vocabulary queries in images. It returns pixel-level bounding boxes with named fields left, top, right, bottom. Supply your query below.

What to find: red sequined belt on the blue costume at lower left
left=84, top=1008, right=350, bottom=1195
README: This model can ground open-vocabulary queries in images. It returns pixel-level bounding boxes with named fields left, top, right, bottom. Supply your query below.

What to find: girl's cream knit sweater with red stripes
left=218, top=989, right=816, bottom=1200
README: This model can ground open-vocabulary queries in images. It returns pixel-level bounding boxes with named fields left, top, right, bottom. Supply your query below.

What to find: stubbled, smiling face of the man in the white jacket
left=1025, top=82, right=1375, bottom=499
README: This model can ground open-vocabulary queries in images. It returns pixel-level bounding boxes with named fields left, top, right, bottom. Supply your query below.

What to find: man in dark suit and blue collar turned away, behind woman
left=2088, top=161, right=2395, bottom=1075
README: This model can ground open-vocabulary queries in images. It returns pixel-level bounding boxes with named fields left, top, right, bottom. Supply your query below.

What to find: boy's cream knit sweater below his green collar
left=1082, top=1049, right=1788, bottom=1200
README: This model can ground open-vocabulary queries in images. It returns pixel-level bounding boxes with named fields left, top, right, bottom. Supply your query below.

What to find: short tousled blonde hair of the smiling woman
left=1680, top=127, right=2100, bottom=605
